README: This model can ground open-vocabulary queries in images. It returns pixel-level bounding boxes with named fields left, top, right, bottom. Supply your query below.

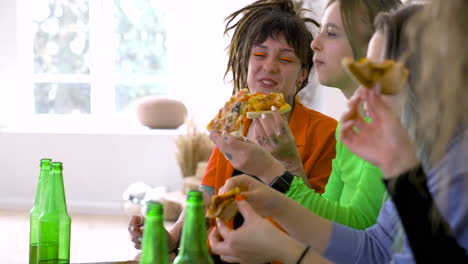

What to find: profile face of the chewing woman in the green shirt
left=311, top=1, right=353, bottom=89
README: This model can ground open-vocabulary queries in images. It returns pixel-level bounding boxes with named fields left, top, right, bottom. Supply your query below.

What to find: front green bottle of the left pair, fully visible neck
left=39, top=162, right=71, bottom=264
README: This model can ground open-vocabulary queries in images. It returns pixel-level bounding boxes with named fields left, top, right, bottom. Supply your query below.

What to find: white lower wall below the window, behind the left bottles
left=0, top=130, right=182, bottom=214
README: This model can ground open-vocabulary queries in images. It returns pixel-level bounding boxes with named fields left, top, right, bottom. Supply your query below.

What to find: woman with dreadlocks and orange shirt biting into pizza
left=202, top=0, right=337, bottom=262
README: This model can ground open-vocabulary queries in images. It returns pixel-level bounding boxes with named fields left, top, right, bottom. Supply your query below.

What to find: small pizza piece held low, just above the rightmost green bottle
left=206, top=187, right=240, bottom=221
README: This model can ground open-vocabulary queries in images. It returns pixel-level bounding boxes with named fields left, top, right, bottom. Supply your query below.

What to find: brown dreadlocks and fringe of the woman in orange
left=224, top=0, right=319, bottom=94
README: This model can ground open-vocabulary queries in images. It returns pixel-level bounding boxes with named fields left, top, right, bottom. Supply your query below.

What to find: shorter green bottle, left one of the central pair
left=140, top=202, right=169, bottom=264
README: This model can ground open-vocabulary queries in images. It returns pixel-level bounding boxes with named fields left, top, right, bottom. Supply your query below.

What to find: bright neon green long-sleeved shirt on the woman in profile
left=286, top=124, right=385, bottom=229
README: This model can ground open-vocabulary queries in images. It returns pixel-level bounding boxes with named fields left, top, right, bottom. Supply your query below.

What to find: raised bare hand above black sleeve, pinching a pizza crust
left=340, top=87, right=419, bottom=178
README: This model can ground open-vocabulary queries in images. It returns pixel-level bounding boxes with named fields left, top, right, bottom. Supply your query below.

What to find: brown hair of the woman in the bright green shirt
left=326, top=0, right=401, bottom=60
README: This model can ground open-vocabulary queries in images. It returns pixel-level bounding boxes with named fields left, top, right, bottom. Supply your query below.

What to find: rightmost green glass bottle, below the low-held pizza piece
left=174, top=191, right=213, bottom=264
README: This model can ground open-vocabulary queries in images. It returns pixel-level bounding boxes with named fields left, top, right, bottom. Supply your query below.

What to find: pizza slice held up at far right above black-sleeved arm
left=342, top=58, right=409, bottom=95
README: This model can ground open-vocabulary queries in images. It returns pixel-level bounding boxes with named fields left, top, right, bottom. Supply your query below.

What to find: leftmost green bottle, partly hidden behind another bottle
left=29, top=159, right=52, bottom=264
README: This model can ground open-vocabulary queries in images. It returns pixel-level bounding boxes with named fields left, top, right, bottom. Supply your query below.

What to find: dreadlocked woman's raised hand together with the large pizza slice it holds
left=207, top=89, right=295, bottom=184
